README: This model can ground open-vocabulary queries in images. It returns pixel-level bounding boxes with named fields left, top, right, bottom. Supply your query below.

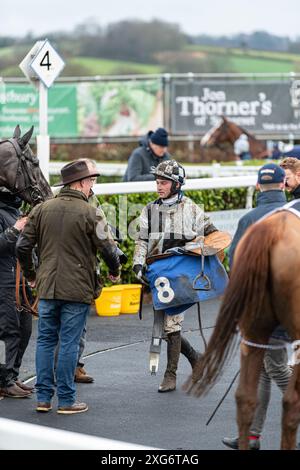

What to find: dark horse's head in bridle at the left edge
left=0, top=126, right=53, bottom=205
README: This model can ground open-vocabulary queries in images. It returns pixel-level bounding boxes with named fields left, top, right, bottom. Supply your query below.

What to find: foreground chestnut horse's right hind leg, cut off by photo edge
left=281, top=364, right=300, bottom=450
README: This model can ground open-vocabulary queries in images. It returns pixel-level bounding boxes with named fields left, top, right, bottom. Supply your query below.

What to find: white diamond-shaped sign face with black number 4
left=30, top=39, right=65, bottom=88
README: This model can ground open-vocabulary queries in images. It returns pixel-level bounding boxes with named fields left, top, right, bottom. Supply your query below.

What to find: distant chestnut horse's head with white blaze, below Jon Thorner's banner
left=200, top=116, right=242, bottom=147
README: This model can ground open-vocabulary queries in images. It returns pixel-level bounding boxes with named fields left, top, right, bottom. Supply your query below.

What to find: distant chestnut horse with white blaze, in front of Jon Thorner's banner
left=200, top=116, right=269, bottom=159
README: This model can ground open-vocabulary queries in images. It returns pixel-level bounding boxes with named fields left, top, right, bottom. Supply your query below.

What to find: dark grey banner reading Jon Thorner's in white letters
left=170, top=79, right=300, bottom=135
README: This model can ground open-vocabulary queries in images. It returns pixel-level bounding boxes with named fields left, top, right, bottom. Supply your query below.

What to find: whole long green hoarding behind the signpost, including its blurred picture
left=0, top=79, right=163, bottom=139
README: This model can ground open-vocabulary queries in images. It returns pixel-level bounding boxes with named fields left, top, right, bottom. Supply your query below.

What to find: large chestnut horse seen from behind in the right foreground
left=185, top=201, right=300, bottom=449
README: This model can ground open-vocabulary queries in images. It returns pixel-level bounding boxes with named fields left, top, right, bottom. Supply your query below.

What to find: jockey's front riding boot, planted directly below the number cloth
left=158, top=331, right=181, bottom=393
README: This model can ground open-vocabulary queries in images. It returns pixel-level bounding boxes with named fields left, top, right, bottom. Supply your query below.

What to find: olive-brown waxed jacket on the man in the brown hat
left=17, top=187, right=120, bottom=304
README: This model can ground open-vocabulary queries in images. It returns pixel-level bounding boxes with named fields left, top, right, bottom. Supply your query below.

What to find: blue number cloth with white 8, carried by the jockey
left=146, top=255, right=228, bottom=315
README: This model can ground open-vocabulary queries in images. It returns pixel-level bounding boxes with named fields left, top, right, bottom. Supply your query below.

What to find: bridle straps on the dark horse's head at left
left=1, top=138, right=43, bottom=205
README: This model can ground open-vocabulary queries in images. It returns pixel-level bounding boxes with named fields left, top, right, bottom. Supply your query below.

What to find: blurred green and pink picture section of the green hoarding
left=77, top=79, right=163, bottom=137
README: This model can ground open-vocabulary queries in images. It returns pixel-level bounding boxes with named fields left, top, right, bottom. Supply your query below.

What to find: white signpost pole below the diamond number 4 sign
left=37, top=80, right=50, bottom=182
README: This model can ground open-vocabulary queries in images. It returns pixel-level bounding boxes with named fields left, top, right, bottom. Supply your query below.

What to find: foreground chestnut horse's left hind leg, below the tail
left=235, top=343, right=265, bottom=450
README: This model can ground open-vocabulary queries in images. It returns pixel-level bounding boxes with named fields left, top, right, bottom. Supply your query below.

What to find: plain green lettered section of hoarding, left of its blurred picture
left=0, top=84, right=78, bottom=139
